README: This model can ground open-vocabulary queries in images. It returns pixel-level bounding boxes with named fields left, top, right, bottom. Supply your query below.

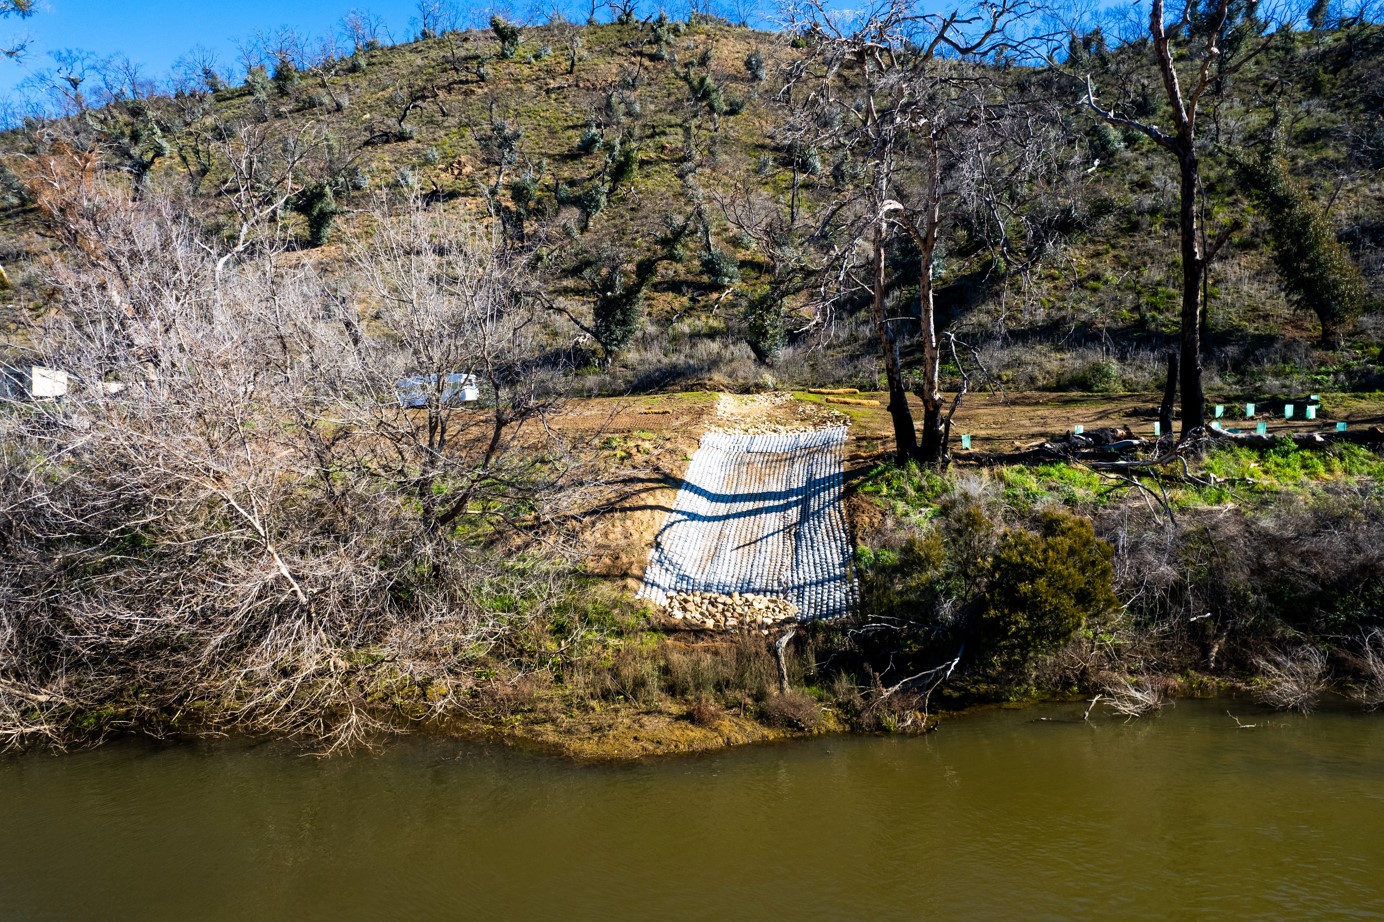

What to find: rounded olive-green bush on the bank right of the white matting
left=976, top=509, right=1120, bottom=671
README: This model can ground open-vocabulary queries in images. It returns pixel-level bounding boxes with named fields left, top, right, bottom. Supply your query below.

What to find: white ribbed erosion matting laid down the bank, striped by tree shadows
left=639, top=426, right=855, bottom=619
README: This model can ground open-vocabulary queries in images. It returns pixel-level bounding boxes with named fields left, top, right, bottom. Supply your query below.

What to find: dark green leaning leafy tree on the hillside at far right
left=1241, top=158, right=1367, bottom=349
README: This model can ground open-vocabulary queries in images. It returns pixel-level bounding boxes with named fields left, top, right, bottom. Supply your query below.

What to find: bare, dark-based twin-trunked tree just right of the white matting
left=787, top=0, right=1028, bottom=464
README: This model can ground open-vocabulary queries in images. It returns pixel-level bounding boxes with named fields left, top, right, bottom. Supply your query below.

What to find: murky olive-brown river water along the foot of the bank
left=0, top=700, right=1384, bottom=921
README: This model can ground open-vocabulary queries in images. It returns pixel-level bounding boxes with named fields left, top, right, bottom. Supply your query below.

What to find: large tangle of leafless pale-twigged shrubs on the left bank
left=0, top=169, right=589, bottom=750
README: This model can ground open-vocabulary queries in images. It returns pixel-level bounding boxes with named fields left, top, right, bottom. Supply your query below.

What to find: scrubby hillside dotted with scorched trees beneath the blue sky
left=0, top=19, right=1384, bottom=395
